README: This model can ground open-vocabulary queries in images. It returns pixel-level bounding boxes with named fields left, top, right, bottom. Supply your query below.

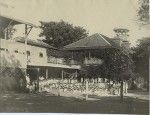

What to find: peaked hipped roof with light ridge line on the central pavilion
left=64, top=33, right=119, bottom=50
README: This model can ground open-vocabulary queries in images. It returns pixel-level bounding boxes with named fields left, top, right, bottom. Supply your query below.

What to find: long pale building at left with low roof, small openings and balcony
left=0, top=37, right=80, bottom=78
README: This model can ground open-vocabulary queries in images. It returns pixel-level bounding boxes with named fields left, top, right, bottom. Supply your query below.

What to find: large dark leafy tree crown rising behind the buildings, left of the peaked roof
left=39, top=21, right=88, bottom=48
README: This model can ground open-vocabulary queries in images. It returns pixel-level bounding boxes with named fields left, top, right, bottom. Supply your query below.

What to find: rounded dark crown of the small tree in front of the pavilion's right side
left=105, top=49, right=134, bottom=80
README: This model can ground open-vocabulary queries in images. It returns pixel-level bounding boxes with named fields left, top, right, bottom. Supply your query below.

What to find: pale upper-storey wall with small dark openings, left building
left=0, top=39, right=47, bottom=68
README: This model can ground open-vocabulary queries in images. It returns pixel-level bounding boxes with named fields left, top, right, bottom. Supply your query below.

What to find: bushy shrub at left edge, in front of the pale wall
left=0, top=56, right=26, bottom=92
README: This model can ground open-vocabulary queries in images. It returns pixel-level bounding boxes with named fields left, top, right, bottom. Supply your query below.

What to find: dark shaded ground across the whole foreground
left=0, top=92, right=149, bottom=114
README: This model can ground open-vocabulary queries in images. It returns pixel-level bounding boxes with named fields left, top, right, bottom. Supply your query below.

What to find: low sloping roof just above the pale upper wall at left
left=15, top=37, right=56, bottom=49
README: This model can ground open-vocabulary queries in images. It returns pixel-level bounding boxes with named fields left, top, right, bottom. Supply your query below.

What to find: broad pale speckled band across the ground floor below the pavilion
left=39, top=72, right=127, bottom=96
